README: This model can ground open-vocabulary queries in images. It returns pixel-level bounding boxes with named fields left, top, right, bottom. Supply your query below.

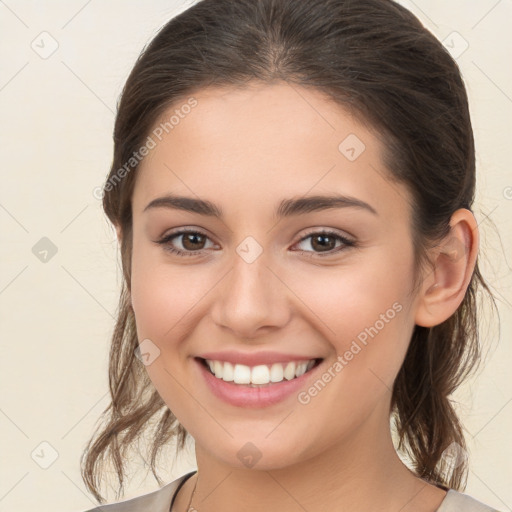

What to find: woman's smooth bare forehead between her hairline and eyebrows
left=133, top=83, right=412, bottom=220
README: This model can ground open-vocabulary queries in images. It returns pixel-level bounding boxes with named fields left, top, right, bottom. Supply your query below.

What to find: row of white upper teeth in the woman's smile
left=206, top=359, right=315, bottom=385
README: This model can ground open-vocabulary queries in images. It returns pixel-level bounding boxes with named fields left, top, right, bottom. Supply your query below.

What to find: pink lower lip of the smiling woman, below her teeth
left=194, top=359, right=323, bottom=407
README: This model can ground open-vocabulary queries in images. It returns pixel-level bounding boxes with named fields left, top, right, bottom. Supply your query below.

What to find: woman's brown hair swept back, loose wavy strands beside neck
left=81, top=0, right=494, bottom=502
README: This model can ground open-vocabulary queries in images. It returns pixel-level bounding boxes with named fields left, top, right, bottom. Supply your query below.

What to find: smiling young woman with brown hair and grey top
left=79, top=0, right=500, bottom=512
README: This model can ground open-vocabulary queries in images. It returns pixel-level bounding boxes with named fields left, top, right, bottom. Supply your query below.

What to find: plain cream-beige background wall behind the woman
left=0, top=0, right=512, bottom=512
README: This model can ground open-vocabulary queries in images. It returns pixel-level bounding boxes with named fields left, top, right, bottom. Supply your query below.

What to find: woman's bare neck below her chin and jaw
left=173, top=400, right=446, bottom=512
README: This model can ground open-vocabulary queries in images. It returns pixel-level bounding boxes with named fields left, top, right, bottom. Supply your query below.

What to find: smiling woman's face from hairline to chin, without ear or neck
left=131, top=84, right=424, bottom=468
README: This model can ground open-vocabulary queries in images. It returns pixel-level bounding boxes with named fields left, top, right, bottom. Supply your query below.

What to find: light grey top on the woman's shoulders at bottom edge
left=80, top=471, right=499, bottom=512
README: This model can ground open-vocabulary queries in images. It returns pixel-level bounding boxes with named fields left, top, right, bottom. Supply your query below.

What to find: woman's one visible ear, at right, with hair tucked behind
left=415, top=208, right=479, bottom=327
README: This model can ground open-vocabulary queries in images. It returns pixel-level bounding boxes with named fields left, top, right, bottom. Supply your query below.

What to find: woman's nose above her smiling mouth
left=211, top=248, right=292, bottom=339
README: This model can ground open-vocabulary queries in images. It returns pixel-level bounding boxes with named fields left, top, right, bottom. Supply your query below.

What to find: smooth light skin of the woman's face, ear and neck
left=118, top=83, right=478, bottom=512
